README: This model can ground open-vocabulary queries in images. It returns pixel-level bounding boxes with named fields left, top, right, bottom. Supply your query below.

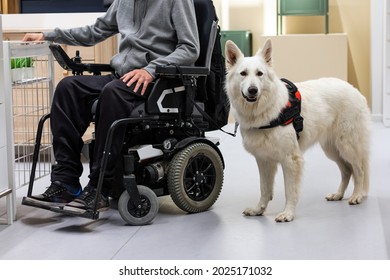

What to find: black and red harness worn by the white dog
left=258, top=78, right=303, bottom=139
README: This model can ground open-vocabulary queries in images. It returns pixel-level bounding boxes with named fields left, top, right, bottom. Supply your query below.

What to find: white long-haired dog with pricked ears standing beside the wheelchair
left=225, top=40, right=370, bottom=222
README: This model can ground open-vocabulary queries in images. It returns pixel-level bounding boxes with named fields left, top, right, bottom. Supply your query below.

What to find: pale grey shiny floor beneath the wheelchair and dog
left=0, top=123, right=390, bottom=260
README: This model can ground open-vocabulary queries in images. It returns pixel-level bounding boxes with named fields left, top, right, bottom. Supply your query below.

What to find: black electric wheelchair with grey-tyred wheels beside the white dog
left=22, top=0, right=225, bottom=225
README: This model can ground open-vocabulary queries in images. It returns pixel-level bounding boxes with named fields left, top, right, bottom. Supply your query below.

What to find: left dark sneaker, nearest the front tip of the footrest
left=31, top=181, right=82, bottom=205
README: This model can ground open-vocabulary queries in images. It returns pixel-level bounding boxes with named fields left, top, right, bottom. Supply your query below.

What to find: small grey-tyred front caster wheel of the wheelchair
left=118, top=185, right=159, bottom=226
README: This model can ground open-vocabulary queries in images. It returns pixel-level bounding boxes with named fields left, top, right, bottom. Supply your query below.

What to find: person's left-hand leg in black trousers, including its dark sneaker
left=33, top=75, right=113, bottom=206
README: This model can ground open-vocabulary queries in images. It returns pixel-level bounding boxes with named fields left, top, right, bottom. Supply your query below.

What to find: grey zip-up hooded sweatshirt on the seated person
left=44, top=0, right=199, bottom=77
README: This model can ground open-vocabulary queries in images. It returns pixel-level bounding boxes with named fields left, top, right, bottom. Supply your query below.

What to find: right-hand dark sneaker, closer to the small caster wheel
left=64, top=185, right=110, bottom=211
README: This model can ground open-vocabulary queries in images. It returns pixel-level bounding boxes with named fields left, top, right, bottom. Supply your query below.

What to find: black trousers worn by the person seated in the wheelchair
left=50, top=75, right=144, bottom=187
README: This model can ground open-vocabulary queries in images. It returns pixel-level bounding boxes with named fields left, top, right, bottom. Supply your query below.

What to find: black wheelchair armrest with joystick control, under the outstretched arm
left=49, top=44, right=114, bottom=73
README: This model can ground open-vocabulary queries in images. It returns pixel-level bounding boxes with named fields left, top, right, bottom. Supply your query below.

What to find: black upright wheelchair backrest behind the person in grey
left=194, top=0, right=218, bottom=68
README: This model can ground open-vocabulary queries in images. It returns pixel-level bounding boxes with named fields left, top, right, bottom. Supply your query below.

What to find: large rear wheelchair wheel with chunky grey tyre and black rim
left=168, top=143, right=223, bottom=213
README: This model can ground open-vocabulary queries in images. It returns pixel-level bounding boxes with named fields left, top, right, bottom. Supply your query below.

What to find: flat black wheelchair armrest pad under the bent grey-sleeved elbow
left=156, top=65, right=210, bottom=78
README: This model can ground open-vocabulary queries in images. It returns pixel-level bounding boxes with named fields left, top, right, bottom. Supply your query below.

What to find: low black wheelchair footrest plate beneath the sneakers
left=22, top=197, right=99, bottom=220
